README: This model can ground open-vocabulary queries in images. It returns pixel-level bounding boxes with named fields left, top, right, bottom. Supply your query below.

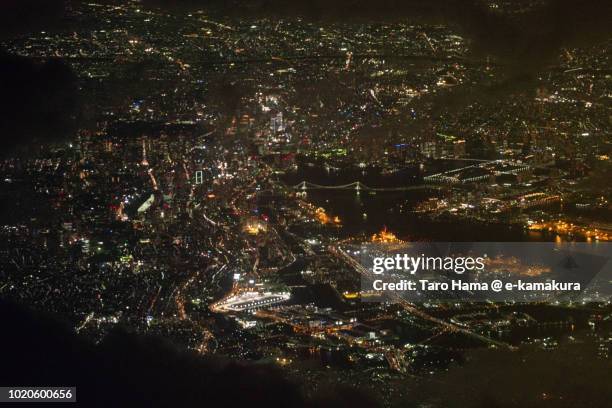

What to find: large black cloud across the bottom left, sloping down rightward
left=0, top=302, right=375, bottom=408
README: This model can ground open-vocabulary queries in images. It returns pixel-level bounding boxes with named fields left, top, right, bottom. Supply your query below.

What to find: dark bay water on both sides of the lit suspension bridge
left=284, top=164, right=554, bottom=241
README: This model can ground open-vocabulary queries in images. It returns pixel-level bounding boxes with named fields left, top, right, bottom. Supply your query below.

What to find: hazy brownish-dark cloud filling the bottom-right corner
left=413, top=343, right=612, bottom=408
